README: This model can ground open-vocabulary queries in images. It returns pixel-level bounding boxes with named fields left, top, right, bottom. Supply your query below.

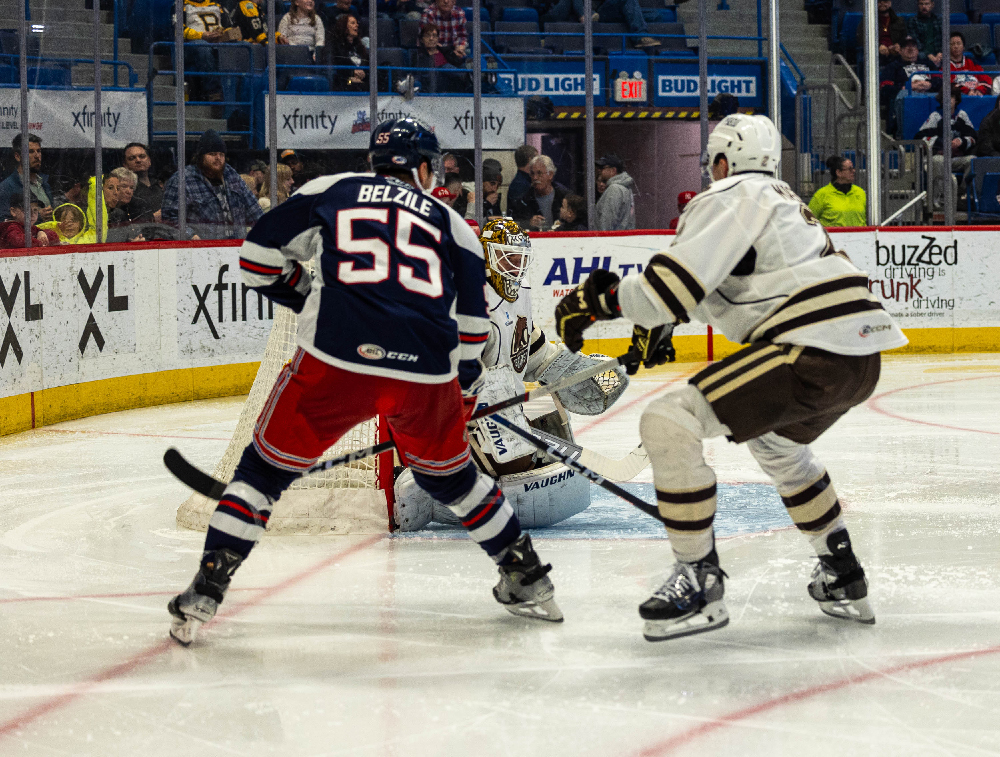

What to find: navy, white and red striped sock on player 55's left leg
left=202, top=444, right=298, bottom=563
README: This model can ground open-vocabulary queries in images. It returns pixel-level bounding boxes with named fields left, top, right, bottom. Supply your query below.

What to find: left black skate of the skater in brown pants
left=639, top=560, right=729, bottom=641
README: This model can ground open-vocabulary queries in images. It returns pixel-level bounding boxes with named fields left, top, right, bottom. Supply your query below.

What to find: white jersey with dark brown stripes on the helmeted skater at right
left=618, top=173, right=907, bottom=355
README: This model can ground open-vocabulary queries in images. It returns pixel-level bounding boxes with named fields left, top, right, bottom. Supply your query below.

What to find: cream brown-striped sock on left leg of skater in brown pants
left=639, top=384, right=727, bottom=563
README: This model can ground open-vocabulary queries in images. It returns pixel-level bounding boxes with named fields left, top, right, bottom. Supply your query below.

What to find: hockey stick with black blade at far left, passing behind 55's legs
left=163, top=350, right=639, bottom=501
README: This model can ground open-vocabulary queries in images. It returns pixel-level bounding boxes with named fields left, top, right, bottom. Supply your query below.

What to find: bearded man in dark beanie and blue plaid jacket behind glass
left=163, top=129, right=263, bottom=239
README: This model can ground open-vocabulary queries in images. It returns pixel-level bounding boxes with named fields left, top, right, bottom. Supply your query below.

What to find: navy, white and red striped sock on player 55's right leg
left=413, top=462, right=521, bottom=560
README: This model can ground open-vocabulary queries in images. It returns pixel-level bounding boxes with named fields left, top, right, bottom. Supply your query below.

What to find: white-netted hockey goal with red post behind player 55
left=177, top=305, right=393, bottom=534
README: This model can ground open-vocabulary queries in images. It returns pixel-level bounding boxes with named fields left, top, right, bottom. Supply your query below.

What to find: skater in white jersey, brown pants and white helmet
left=556, top=114, right=906, bottom=641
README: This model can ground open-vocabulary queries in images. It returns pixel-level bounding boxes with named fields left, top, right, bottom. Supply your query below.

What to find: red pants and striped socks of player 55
left=205, top=349, right=521, bottom=558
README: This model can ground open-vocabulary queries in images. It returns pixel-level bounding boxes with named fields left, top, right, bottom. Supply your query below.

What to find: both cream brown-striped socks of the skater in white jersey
left=639, top=384, right=844, bottom=562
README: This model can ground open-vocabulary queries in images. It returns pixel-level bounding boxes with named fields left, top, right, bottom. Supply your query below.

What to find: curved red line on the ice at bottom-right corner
left=636, top=646, right=1000, bottom=757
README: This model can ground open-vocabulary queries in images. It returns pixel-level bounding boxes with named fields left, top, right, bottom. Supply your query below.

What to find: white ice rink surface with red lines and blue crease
left=0, top=355, right=1000, bottom=757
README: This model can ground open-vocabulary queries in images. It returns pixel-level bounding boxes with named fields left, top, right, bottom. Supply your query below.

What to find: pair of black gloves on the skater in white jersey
left=556, top=268, right=677, bottom=376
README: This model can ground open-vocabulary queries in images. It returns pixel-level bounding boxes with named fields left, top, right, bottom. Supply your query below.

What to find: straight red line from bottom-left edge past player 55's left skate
left=0, top=535, right=383, bottom=739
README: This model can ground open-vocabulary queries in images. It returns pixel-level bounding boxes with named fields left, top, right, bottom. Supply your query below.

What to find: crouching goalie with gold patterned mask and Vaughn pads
left=395, top=218, right=628, bottom=531
